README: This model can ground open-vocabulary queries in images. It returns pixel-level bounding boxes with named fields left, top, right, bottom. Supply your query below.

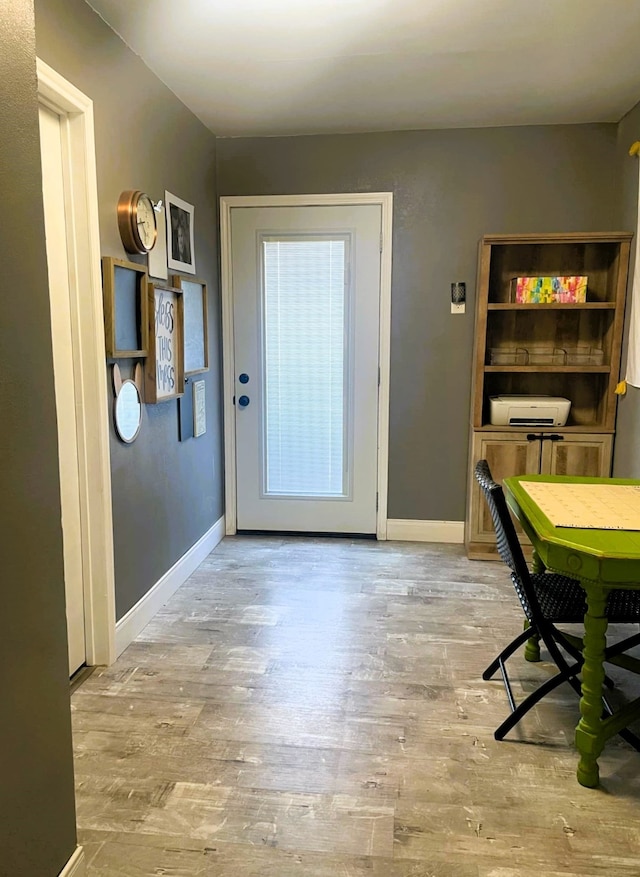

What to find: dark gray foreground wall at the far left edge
left=0, top=0, right=76, bottom=877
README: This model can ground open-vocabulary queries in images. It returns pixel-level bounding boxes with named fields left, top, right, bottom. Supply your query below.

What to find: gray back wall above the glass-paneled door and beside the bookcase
left=218, top=125, right=617, bottom=521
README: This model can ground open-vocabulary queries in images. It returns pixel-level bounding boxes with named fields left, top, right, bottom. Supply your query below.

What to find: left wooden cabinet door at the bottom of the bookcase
left=467, top=432, right=540, bottom=544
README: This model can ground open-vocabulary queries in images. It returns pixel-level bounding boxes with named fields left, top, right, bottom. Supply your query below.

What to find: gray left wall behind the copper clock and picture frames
left=36, top=0, right=223, bottom=618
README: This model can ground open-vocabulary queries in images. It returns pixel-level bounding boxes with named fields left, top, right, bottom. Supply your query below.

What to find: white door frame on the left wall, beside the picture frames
left=36, top=58, right=116, bottom=665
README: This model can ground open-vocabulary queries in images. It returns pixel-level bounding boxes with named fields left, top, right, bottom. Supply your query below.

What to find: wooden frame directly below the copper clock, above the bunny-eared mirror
left=102, top=256, right=149, bottom=359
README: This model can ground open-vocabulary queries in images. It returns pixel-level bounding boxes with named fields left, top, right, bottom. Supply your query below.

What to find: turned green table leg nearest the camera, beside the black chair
left=576, top=583, right=607, bottom=788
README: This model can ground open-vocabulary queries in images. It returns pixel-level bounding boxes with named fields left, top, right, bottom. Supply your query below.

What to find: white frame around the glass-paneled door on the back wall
left=220, top=192, right=393, bottom=540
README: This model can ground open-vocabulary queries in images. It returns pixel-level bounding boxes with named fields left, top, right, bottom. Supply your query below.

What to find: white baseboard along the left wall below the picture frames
left=116, top=515, right=225, bottom=657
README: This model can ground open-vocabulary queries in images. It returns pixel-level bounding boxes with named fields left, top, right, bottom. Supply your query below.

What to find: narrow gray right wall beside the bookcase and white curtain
left=613, top=98, right=640, bottom=478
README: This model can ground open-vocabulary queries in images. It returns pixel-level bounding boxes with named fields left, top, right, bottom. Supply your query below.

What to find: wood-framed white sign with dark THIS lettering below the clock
left=144, top=283, right=184, bottom=402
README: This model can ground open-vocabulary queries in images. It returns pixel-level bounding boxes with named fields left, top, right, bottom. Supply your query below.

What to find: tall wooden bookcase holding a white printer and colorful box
left=465, top=232, right=632, bottom=559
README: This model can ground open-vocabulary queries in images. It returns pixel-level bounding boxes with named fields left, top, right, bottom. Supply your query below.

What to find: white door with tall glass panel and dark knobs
left=231, top=204, right=382, bottom=534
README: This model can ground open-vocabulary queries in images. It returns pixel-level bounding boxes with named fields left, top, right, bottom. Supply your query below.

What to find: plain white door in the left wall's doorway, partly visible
left=40, top=106, right=86, bottom=675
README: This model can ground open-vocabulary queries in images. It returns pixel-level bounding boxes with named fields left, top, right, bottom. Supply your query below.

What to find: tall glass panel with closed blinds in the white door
left=262, top=235, right=350, bottom=499
